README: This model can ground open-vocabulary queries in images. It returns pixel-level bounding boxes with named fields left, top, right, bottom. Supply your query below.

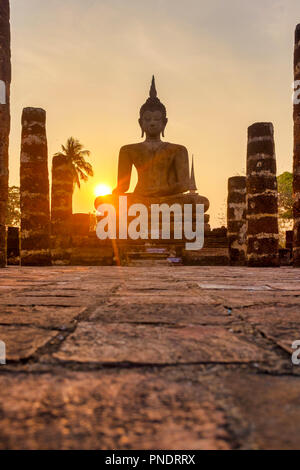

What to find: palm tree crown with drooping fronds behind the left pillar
left=54, top=137, right=94, bottom=188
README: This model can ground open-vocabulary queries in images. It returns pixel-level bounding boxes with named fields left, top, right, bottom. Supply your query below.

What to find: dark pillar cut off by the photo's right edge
left=293, top=24, right=300, bottom=268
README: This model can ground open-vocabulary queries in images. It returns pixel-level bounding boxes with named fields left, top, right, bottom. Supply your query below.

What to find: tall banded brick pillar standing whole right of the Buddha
left=247, top=122, right=279, bottom=267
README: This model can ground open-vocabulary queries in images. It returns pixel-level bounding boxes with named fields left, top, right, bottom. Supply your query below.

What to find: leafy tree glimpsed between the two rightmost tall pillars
left=277, top=171, right=293, bottom=247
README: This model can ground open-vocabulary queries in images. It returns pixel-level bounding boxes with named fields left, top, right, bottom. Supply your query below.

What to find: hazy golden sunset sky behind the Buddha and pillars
left=10, top=0, right=300, bottom=226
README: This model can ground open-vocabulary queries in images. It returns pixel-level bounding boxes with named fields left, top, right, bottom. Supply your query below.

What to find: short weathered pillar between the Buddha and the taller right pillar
left=227, top=176, right=247, bottom=266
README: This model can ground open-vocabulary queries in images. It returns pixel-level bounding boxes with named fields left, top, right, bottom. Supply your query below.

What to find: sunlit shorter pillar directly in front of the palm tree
left=51, top=156, right=73, bottom=265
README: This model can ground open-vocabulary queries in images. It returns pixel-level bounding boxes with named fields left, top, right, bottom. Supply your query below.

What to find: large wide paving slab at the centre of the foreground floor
left=54, top=322, right=276, bottom=364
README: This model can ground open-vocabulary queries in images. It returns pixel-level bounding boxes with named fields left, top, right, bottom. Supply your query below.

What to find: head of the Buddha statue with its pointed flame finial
left=139, top=76, right=168, bottom=137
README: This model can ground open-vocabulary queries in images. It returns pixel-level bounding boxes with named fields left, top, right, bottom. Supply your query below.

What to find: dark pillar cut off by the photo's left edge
left=0, top=0, right=11, bottom=268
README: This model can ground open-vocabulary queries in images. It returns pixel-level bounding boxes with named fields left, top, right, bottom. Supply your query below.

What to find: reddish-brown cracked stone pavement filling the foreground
left=0, top=267, right=300, bottom=449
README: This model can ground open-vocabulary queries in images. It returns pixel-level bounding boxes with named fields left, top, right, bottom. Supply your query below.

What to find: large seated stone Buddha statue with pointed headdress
left=95, top=76, right=209, bottom=224
